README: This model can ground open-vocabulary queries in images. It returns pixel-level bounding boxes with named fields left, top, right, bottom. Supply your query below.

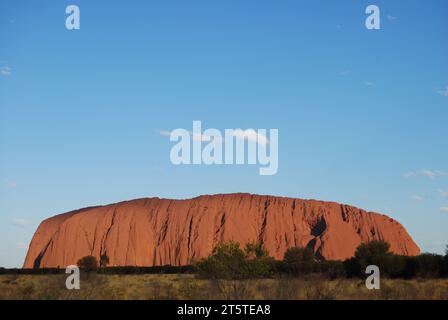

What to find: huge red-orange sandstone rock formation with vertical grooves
left=24, top=194, right=420, bottom=268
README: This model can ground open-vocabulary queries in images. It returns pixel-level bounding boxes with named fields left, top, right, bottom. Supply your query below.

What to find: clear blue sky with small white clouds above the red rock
left=0, top=0, right=448, bottom=267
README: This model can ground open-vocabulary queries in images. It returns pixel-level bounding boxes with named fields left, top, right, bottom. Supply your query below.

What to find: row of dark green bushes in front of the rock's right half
left=193, top=241, right=448, bottom=279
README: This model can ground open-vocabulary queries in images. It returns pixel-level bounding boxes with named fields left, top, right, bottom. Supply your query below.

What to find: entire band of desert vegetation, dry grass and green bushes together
left=0, top=241, right=448, bottom=300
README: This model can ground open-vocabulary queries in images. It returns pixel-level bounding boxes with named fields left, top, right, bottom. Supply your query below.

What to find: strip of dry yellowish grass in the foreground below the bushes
left=0, top=274, right=448, bottom=300
